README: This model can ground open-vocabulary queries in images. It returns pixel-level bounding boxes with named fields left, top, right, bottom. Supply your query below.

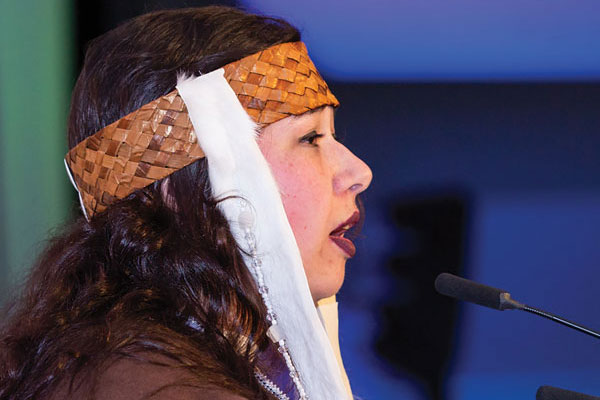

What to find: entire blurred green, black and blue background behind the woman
left=0, top=0, right=600, bottom=400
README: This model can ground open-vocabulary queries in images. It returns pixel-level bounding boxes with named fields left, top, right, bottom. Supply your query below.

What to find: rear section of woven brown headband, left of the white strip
left=67, top=90, right=204, bottom=217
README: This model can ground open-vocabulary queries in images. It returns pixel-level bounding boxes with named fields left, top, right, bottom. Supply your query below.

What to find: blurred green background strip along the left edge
left=0, top=0, right=73, bottom=297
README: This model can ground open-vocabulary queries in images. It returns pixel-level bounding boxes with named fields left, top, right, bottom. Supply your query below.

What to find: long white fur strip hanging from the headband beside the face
left=177, top=69, right=350, bottom=400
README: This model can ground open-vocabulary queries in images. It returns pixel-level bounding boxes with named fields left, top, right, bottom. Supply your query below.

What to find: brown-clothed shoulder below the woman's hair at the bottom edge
left=51, top=355, right=245, bottom=400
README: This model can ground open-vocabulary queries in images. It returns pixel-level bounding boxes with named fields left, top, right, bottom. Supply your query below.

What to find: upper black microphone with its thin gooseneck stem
left=435, top=272, right=600, bottom=339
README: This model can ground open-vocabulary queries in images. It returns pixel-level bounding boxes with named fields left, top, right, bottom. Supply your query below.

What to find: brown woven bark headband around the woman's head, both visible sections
left=65, top=42, right=339, bottom=218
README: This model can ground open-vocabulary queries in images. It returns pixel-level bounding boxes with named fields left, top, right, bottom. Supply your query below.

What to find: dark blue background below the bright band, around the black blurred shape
left=334, top=83, right=600, bottom=399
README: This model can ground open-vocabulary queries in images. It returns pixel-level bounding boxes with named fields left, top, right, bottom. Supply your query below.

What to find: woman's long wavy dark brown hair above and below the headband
left=0, top=7, right=300, bottom=399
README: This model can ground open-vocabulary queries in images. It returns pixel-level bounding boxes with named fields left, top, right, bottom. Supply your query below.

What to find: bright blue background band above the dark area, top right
left=240, top=0, right=600, bottom=81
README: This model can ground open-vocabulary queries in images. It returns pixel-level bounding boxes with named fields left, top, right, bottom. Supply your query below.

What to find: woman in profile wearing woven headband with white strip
left=0, top=7, right=371, bottom=399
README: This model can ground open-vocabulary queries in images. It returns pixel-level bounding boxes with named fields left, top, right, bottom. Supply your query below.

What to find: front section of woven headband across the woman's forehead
left=223, top=42, right=339, bottom=125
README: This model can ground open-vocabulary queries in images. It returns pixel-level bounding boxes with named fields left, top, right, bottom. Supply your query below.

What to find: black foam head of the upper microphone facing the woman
left=435, top=272, right=506, bottom=310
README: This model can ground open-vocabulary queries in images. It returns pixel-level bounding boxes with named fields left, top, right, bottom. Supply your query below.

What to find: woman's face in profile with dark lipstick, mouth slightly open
left=258, top=107, right=372, bottom=302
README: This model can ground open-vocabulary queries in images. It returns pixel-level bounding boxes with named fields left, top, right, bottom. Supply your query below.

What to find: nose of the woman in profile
left=333, top=143, right=373, bottom=195
